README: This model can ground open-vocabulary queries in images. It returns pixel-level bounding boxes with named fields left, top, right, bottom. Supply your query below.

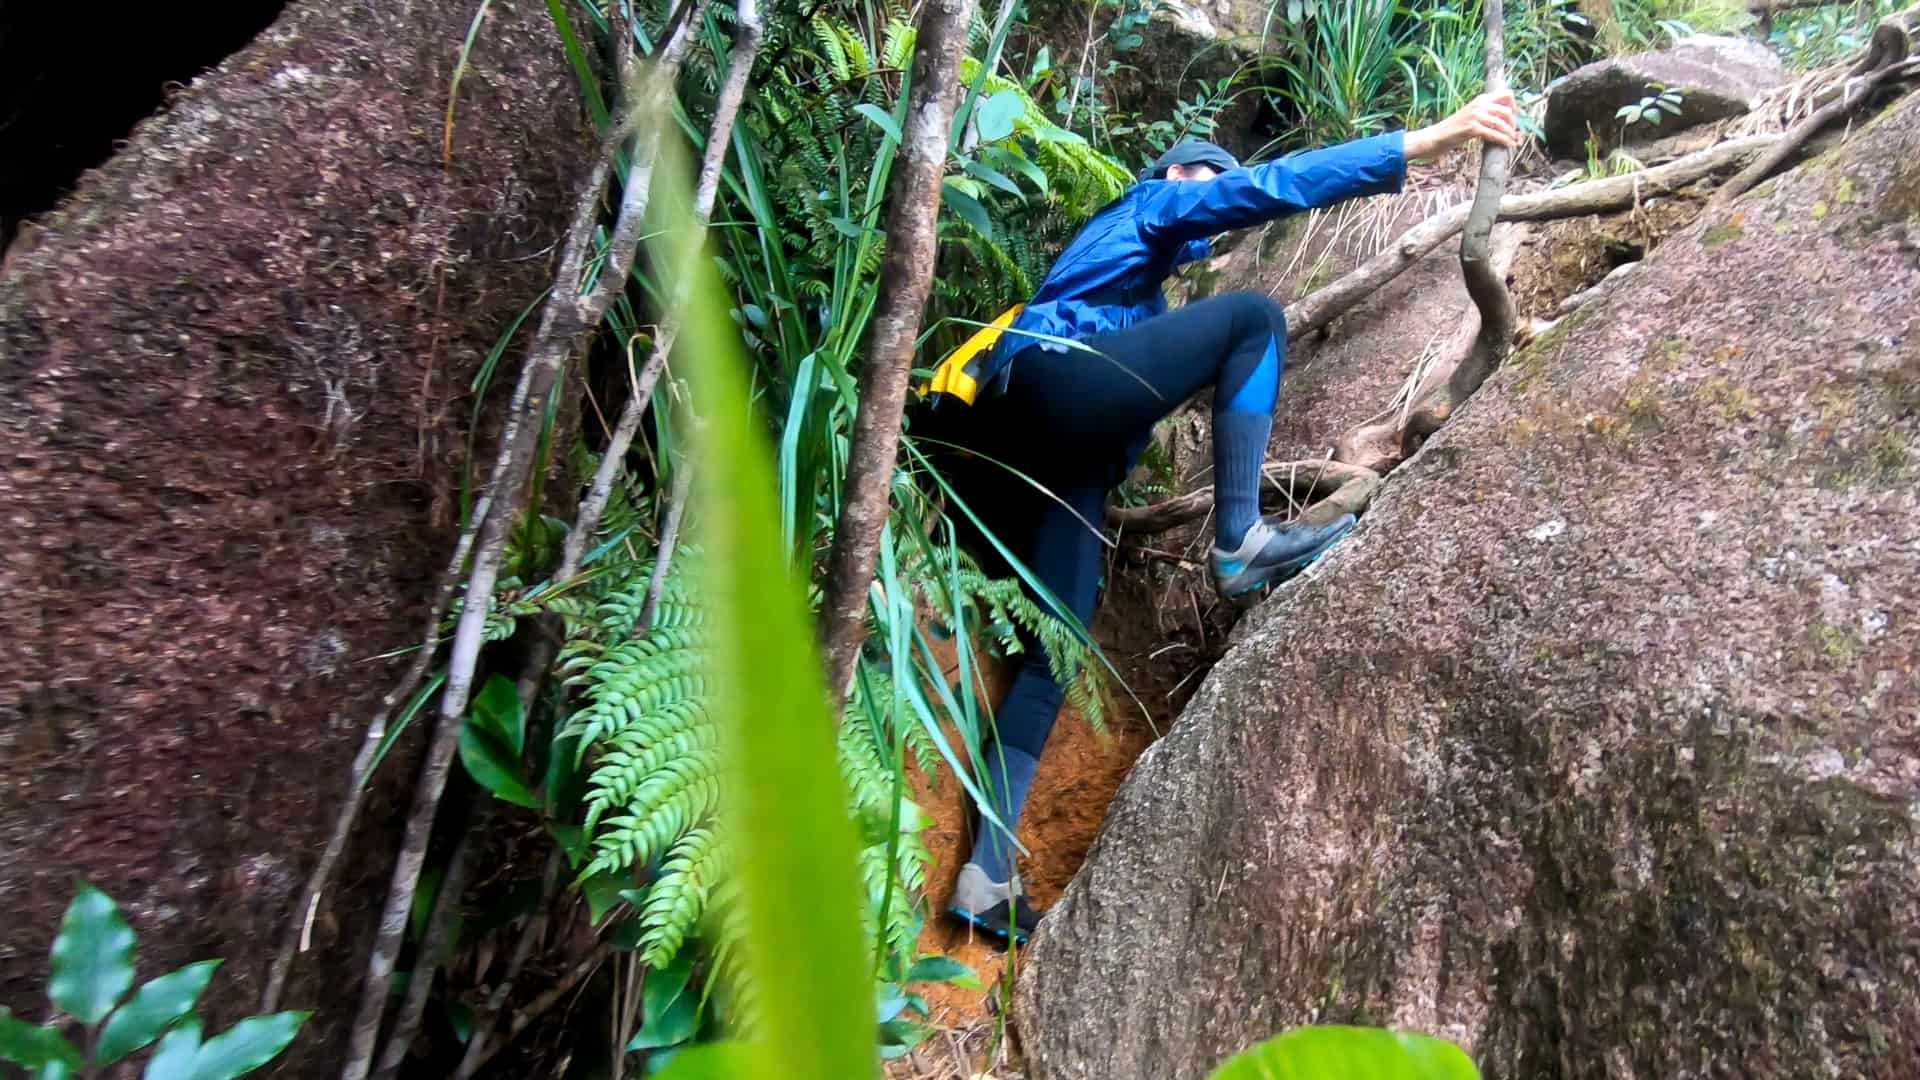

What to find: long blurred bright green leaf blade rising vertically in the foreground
left=655, top=138, right=876, bottom=1080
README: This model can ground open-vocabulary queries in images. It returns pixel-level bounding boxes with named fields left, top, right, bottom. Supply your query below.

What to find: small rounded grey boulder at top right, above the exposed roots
left=1542, top=35, right=1786, bottom=160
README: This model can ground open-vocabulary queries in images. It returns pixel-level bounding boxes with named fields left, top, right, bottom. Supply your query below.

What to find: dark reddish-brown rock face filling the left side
left=0, top=0, right=589, bottom=1076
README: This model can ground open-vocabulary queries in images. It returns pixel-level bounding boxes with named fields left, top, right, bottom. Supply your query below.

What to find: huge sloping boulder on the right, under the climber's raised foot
left=1016, top=96, right=1920, bottom=1080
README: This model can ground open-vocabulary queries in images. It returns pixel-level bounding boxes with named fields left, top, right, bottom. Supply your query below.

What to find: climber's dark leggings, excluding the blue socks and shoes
left=929, top=292, right=1286, bottom=757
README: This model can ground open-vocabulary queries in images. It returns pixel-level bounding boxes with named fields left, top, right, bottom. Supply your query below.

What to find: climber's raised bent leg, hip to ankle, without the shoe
left=1016, top=292, right=1286, bottom=548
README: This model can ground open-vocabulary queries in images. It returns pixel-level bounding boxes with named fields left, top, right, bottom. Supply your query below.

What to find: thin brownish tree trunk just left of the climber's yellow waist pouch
left=820, top=0, right=973, bottom=713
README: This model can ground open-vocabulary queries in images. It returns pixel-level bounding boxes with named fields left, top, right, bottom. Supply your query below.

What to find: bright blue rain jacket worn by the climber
left=979, top=131, right=1407, bottom=390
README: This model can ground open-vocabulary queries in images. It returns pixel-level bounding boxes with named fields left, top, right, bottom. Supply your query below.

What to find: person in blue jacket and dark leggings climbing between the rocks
left=927, top=92, right=1519, bottom=942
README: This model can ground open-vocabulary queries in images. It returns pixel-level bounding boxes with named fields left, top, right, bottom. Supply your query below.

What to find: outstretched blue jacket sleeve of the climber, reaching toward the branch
left=1135, top=131, right=1407, bottom=250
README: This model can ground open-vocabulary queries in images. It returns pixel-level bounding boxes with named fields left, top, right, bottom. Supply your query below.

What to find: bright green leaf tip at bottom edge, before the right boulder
left=1212, top=1026, right=1480, bottom=1080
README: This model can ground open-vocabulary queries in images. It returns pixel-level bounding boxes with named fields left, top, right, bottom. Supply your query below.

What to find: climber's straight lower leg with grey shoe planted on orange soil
left=952, top=470, right=1106, bottom=940
